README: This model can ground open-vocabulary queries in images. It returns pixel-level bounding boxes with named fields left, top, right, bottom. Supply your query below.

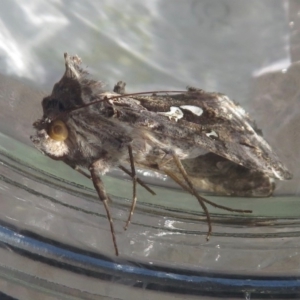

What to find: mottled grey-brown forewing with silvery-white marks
left=110, top=90, right=292, bottom=180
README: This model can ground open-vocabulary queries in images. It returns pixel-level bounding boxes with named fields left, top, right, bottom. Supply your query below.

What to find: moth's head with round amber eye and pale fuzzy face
left=30, top=119, right=69, bottom=159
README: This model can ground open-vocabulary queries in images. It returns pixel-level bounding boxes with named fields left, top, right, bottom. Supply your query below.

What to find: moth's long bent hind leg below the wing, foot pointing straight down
left=173, top=154, right=212, bottom=241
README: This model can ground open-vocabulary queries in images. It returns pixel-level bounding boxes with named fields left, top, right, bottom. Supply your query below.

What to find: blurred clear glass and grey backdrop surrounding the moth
left=0, top=0, right=300, bottom=299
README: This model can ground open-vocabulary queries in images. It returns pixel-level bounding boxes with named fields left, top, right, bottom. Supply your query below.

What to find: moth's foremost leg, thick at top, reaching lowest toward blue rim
left=89, top=161, right=119, bottom=256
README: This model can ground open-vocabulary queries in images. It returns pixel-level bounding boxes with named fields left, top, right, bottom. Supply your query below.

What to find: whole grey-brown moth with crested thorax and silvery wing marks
left=30, top=53, right=292, bottom=255
